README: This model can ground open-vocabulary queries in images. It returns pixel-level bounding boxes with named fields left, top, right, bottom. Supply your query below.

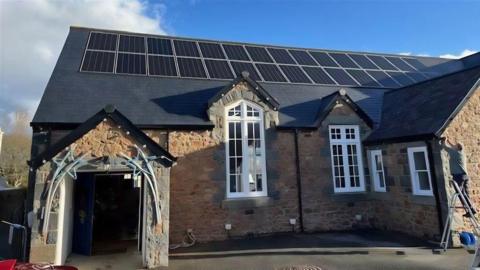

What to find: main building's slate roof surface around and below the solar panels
left=31, top=27, right=480, bottom=142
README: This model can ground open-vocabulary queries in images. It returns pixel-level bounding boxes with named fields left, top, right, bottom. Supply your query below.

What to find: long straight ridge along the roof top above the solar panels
left=70, top=25, right=452, bottom=60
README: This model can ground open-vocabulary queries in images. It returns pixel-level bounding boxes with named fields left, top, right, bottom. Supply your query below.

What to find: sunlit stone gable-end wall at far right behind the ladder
left=442, top=88, right=480, bottom=244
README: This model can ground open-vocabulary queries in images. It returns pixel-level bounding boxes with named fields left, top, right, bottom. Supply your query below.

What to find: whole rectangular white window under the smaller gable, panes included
left=329, top=125, right=365, bottom=192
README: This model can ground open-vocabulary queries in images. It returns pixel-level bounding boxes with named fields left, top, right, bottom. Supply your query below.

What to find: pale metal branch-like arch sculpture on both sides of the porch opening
left=41, top=145, right=164, bottom=238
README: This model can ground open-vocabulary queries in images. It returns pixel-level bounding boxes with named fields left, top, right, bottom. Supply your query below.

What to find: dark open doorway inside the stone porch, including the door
left=72, top=172, right=142, bottom=255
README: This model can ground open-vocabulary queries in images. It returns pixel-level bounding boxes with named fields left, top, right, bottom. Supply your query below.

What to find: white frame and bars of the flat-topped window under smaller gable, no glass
left=328, top=125, right=365, bottom=193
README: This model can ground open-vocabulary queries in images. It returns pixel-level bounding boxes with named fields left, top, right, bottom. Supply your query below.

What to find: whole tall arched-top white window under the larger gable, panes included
left=225, top=100, right=267, bottom=198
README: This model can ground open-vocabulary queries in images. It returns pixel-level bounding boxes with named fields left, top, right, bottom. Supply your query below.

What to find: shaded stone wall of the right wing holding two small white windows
left=367, top=142, right=440, bottom=239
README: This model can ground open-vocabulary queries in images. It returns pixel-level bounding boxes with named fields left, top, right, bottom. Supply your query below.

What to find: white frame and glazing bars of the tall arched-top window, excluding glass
left=224, top=100, right=268, bottom=198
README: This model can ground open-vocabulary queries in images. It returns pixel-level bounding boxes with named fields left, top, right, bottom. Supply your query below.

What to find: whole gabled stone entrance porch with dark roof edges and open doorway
left=27, top=106, right=176, bottom=268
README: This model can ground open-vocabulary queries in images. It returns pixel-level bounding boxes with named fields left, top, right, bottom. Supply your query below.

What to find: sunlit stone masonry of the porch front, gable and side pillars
left=30, top=120, right=170, bottom=268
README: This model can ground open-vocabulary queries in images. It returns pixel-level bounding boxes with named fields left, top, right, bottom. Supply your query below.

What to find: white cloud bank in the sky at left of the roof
left=0, top=0, right=169, bottom=129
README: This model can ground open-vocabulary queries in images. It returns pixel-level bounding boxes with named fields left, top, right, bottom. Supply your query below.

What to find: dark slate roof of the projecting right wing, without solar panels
left=367, top=63, right=480, bottom=142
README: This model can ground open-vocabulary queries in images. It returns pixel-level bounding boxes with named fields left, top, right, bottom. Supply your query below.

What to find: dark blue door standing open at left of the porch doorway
left=72, top=173, right=95, bottom=256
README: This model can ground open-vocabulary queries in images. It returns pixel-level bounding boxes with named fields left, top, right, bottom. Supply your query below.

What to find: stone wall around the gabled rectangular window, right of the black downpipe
left=299, top=102, right=374, bottom=232
